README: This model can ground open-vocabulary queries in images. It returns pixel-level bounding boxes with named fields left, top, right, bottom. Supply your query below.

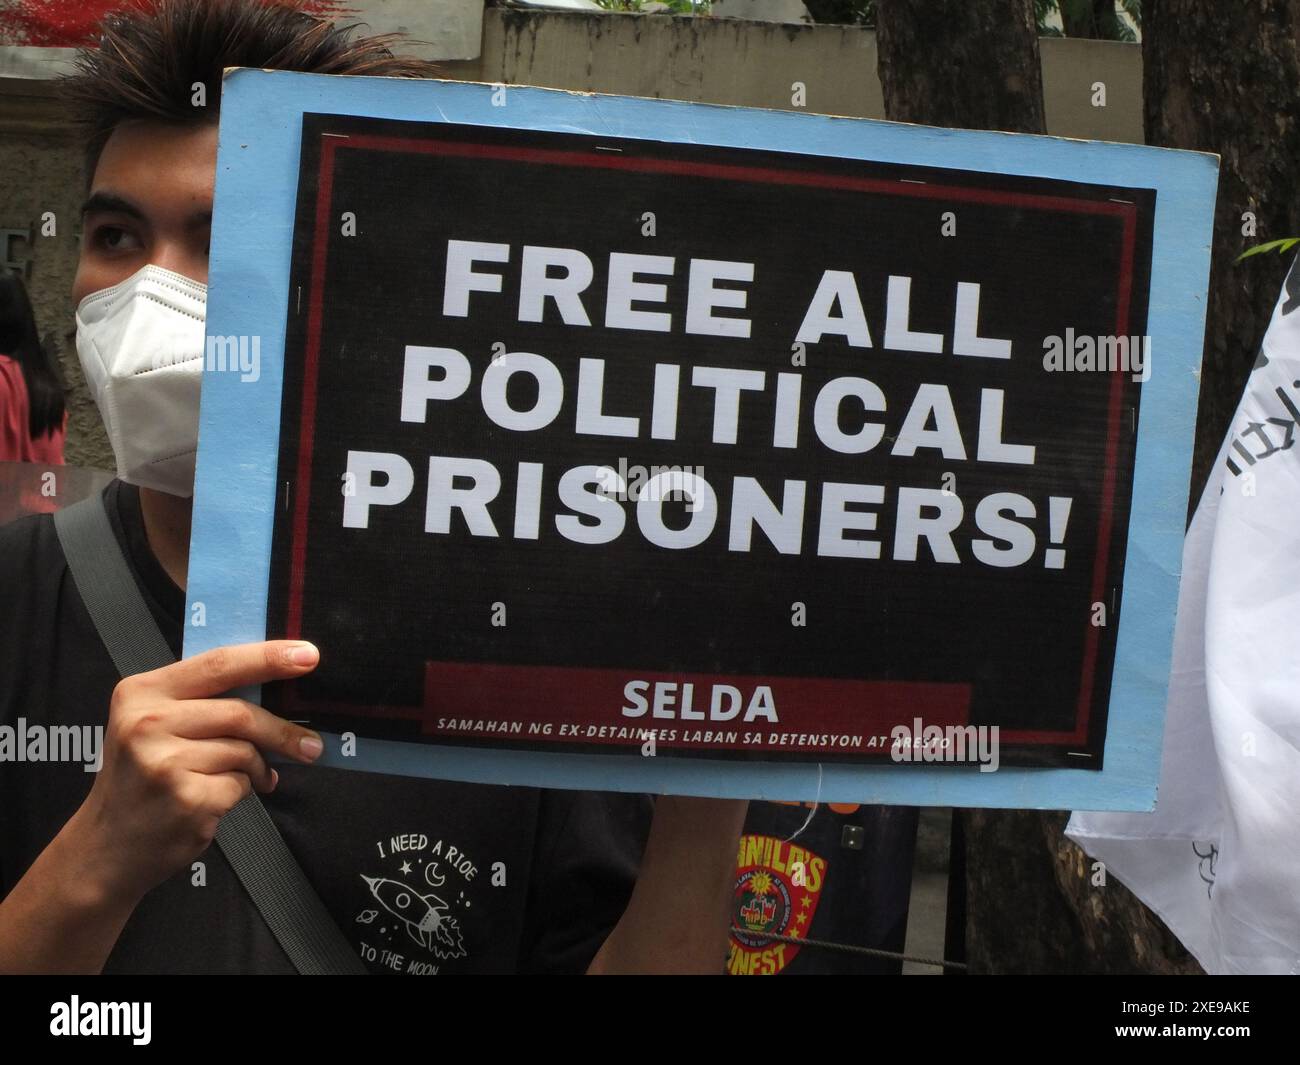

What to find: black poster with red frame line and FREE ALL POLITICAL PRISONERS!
left=258, top=114, right=1154, bottom=769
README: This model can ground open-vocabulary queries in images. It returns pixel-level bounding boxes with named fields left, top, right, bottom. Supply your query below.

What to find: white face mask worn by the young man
left=77, top=265, right=208, bottom=497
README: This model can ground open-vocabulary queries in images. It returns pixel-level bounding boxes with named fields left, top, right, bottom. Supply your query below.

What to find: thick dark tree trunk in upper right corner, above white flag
left=1143, top=0, right=1300, bottom=507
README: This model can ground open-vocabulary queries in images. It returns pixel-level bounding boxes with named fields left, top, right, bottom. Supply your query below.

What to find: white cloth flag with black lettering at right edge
left=1066, top=260, right=1300, bottom=974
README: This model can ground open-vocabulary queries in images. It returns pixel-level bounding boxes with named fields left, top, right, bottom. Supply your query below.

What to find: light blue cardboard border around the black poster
left=185, top=69, right=1218, bottom=810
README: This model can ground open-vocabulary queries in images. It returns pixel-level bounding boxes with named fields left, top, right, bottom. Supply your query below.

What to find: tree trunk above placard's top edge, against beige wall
left=876, top=0, right=1047, bottom=133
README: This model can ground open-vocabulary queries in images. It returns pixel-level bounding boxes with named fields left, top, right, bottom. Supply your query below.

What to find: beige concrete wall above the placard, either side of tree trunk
left=465, top=8, right=1141, bottom=143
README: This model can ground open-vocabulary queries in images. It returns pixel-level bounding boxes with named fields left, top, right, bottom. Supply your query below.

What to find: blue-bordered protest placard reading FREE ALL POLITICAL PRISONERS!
left=186, top=72, right=1216, bottom=808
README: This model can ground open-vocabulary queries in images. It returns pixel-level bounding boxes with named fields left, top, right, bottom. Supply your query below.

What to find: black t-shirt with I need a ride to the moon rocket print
left=0, top=481, right=653, bottom=974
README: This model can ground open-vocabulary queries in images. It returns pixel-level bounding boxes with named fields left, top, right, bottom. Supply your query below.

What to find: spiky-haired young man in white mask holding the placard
left=0, top=0, right=745, bottom=974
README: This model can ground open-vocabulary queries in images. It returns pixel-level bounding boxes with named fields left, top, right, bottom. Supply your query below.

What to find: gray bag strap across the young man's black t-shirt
left=55, top=492, right=367, bottom=975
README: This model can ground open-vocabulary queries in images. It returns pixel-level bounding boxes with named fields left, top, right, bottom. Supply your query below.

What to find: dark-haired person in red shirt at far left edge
left=0, top=274, right=68, bottom=466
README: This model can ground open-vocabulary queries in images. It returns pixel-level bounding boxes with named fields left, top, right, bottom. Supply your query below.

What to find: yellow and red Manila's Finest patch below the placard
left=727, top=836, right=826, bottom=977
